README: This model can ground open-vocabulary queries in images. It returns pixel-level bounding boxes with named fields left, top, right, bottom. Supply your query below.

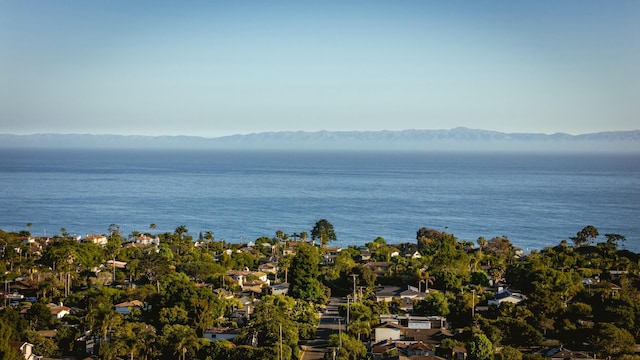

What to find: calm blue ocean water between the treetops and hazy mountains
left=0, top=150, right=640, bottom=252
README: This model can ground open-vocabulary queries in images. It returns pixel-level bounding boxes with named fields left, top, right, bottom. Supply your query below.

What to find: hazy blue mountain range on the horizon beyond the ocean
left=0, top=128, right=640, bottom=153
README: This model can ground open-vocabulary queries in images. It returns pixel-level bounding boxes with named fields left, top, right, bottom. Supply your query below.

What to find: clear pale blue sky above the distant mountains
left=0, top=0, right=640, bottom=136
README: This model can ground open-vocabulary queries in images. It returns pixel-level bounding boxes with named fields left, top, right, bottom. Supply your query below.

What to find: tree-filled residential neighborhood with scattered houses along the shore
left=0, top=224, right=640, bottom=360
